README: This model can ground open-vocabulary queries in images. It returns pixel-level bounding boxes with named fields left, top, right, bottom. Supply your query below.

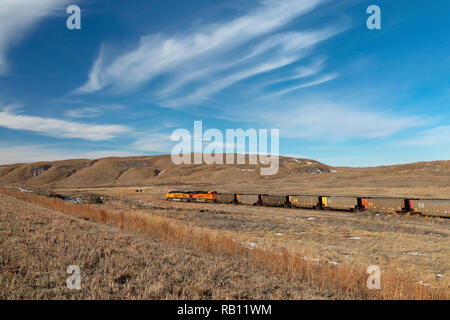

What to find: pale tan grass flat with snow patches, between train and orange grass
left=63, top=188, right=450, bottom=284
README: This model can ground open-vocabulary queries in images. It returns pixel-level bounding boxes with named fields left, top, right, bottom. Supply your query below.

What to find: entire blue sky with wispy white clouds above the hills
left=0, top=0, right=450, bottom=166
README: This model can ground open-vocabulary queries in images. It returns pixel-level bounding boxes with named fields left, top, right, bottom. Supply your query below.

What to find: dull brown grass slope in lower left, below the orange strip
left=0, top=195, right=342, bottom=299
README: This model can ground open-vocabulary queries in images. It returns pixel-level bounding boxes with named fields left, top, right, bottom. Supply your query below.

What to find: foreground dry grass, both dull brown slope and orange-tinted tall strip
left=0, top=189, right=450, bottom=299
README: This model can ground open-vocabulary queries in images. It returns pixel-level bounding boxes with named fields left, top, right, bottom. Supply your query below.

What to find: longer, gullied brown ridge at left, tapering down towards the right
left=0, top=155, right=334, bottom=187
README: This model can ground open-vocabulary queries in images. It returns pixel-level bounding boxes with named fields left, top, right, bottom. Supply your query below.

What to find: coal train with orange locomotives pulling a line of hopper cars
left=166, top=191, right=450, bottom=218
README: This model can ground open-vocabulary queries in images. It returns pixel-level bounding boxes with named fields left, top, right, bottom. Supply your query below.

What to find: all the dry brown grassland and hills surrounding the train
left=0, top=156, right=450, bottom=299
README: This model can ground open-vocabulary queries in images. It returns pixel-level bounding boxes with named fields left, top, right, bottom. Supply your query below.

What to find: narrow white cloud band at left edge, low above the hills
left=0, top=108, right=130, bottom=141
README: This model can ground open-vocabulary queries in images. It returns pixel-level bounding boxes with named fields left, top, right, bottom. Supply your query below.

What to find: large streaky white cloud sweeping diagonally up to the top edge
left=76, top=0, right=342, bottom=101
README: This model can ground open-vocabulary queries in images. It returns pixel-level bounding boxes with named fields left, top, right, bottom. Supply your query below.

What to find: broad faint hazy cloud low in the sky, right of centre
left=226, top=98, right=426, bottom=143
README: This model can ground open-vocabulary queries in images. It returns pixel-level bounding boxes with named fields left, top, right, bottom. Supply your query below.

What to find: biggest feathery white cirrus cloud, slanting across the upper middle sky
left=76, top=0, right=337, bottom=94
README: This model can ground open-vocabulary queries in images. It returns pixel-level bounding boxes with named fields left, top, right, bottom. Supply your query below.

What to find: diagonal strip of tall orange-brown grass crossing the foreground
left=0, top=188, right=450, bottom=300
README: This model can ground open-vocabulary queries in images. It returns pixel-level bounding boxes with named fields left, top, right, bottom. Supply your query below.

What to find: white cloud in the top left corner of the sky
left=0, top=0, right=69, bottom=74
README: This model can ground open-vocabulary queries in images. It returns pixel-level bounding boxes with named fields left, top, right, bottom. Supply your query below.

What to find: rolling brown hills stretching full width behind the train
left=0, top=155, right=450, bottom=198
